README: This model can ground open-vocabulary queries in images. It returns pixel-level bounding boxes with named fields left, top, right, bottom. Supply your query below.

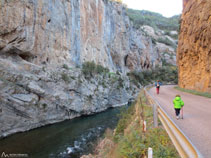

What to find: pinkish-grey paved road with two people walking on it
left=149, top=86, right=211, bottom=158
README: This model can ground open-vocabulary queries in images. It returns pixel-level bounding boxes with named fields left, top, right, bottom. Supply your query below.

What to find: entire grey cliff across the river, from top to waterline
left=0, top=0, right=178, bottom=137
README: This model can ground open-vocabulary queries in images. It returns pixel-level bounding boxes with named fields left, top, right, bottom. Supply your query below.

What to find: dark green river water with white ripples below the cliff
left=0, top=107, right=125, bottom=158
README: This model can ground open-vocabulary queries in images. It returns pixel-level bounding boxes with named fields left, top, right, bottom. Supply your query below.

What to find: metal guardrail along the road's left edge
left=144, top=85, right=203, bottom=158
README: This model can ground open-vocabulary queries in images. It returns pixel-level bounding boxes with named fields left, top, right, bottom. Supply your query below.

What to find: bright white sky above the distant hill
left=122, top=0, right=182, bottom=17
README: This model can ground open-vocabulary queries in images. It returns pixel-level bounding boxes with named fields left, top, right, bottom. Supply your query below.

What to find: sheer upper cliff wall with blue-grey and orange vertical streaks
left=0, top=0, right=160, bottom=72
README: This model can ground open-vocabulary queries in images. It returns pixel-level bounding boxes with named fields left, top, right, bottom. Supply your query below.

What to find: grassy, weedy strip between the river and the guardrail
left=82, top=92, right=179, bottom=158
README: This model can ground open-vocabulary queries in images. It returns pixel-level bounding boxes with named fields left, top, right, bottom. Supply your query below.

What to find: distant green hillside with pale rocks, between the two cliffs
left=126, top=8, right=180, bottom=65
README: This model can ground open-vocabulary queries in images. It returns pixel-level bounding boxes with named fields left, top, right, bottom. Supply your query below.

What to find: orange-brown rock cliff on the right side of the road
left=177, top=0, right=211, bottom=92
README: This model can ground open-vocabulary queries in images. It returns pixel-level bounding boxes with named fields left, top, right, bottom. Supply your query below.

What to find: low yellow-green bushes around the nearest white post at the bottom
left=119, top=128, right=179, bottom=158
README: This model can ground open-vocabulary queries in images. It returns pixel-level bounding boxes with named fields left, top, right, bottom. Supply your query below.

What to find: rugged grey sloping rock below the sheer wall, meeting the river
left=0, top=59, right=138, bottom=137
